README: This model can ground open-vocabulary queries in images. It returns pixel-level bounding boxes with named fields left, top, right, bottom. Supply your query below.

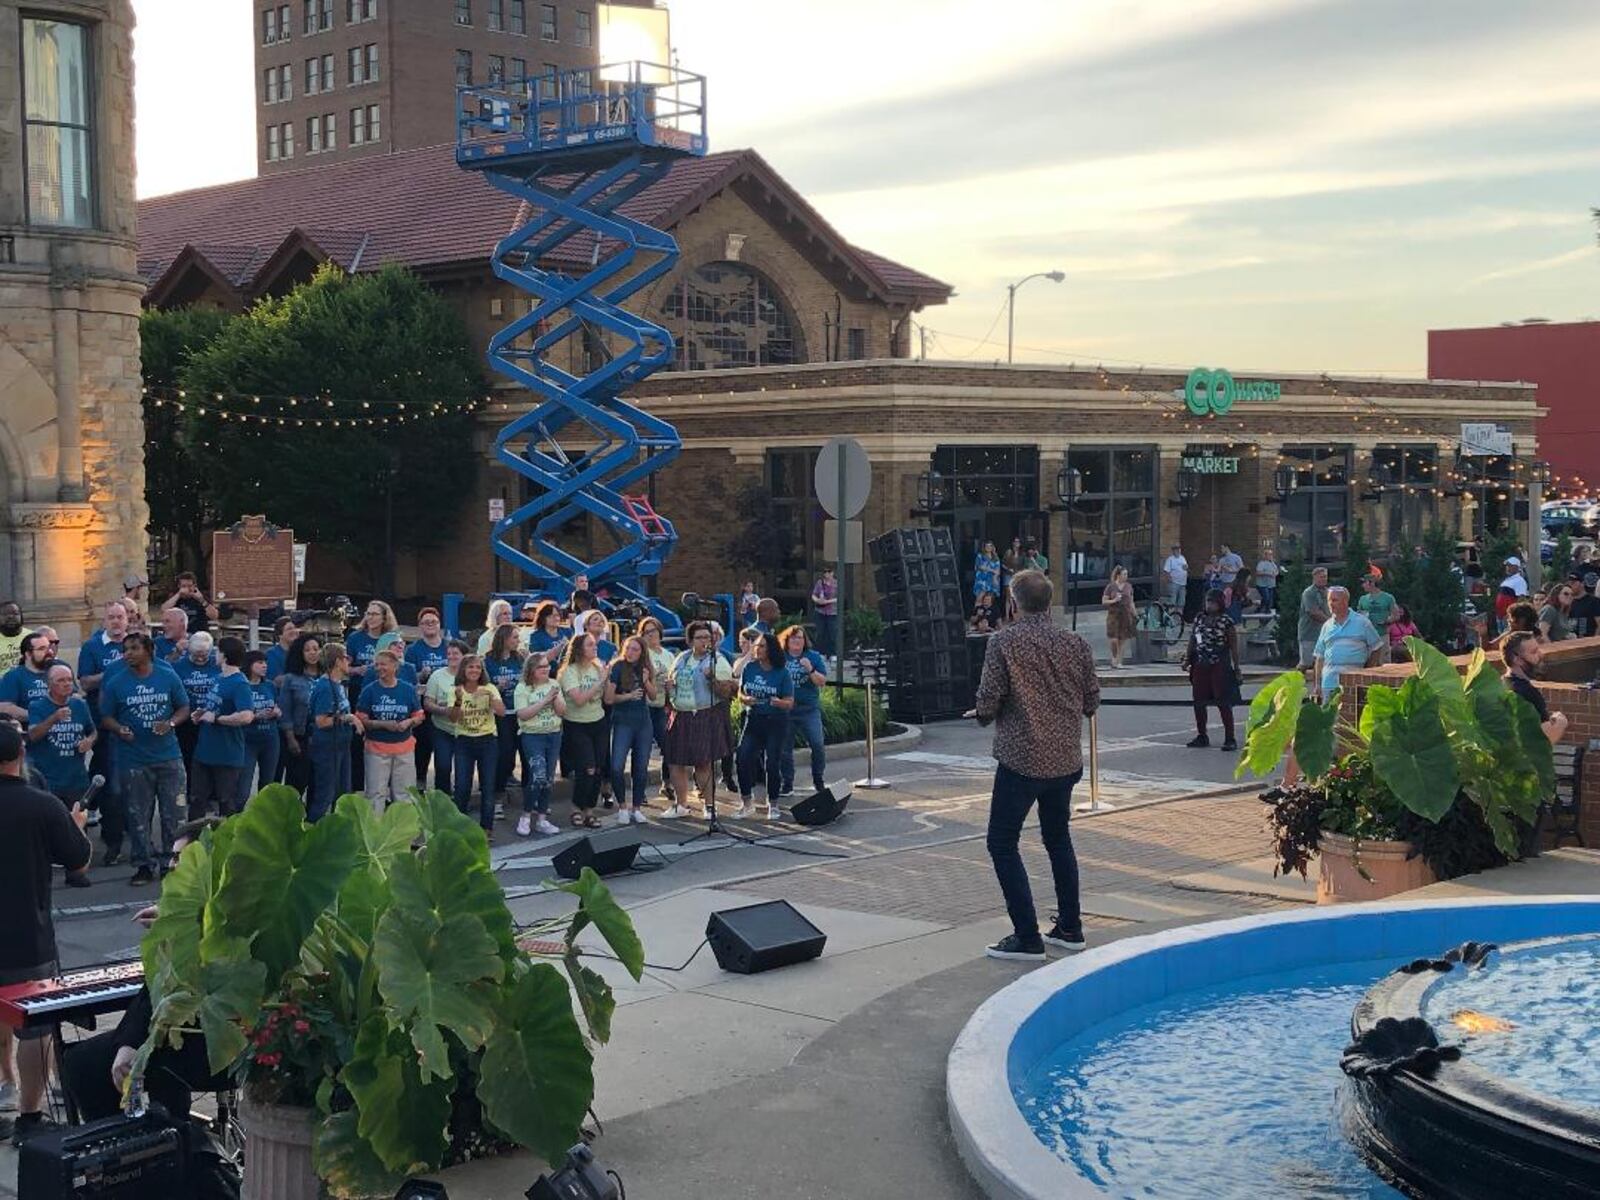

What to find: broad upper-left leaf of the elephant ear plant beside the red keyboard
left=218, top=786, right=357, bottom=981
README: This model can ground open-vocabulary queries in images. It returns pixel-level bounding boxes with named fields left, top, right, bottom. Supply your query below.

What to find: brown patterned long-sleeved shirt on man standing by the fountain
left=976, top=613, right=1099, bottom=779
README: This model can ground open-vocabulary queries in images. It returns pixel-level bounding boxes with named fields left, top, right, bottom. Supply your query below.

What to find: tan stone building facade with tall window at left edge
left=0, top=0, right=147, bottom=645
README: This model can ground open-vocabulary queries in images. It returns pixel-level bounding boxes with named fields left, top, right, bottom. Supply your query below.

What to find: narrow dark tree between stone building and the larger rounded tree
left=139, top=309, right=232, bottom=574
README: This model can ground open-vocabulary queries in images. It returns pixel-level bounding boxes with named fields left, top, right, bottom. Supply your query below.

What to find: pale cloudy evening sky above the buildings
left=134, top=0, right=1600, bottom=374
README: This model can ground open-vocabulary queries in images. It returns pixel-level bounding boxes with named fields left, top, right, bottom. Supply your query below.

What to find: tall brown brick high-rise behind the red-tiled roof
left=251, top=0, right=666, bottom=174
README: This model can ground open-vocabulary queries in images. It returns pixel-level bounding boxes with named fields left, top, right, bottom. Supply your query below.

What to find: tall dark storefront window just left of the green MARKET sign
left=1066, top=446, right=1157, bottom=603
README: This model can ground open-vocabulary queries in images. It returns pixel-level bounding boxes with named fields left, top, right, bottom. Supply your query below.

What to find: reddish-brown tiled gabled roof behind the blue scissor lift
left=139, top=146, right=950, bottom=304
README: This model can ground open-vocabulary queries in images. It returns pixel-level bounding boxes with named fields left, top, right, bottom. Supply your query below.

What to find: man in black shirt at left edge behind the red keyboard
left=0, top=720, right=90, bottom=1142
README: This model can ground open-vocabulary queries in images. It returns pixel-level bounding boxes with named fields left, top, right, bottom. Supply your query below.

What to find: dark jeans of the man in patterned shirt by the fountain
left=987, top=765, right=1083, bottom=942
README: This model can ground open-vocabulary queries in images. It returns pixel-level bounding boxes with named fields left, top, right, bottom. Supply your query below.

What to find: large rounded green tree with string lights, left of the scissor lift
left=179, top=266, right=483, bottom=594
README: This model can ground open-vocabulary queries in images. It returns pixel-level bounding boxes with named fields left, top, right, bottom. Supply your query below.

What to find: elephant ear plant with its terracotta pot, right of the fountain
left=1235, top=637, right=1555, bottom=902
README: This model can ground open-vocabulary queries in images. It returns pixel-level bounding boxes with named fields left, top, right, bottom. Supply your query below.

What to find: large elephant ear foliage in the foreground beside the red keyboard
left=139, top=784, right=645, bottom=1197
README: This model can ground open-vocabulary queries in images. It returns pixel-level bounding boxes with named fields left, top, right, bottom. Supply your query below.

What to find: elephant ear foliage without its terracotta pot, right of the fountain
left=1235, top=637, right=1555, bottom=878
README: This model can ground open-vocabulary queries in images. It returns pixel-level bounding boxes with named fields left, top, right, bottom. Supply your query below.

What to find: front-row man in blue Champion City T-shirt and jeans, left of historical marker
left=99, top=634, right=189, bottom=886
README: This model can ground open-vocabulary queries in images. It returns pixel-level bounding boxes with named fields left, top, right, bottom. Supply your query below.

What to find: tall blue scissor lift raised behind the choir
left=445, top=62, right=706, bottom=632
